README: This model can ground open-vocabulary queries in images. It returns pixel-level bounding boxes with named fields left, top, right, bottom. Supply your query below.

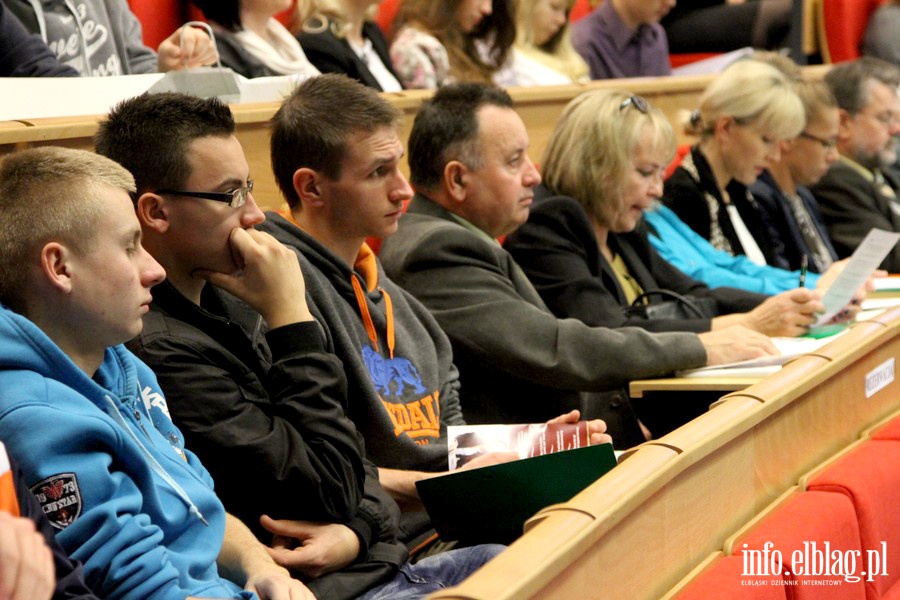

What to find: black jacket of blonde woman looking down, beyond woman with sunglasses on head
left=663, top=146, right=788, bottom=269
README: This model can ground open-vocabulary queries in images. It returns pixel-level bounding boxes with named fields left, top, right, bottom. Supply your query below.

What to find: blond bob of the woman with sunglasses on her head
left=541, top=89, right=675, bottom=219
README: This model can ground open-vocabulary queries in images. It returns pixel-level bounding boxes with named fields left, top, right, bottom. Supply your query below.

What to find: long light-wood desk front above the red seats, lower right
left=431, top=309, right=900, bottom=600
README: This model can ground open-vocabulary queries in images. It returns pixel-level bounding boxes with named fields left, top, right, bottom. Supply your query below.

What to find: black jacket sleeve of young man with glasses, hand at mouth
left=132, top=313, right=365, bottom=534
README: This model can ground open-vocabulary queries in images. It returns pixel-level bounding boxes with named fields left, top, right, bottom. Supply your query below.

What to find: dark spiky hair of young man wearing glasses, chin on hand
left=94, top=93, right=234, bottom=194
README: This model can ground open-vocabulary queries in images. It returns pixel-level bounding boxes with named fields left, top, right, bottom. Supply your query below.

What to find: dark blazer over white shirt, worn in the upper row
left=297, top=21, right=400, bottom=91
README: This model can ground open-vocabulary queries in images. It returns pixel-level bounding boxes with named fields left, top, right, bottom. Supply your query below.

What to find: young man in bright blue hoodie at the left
left=0, top=147, right=312, bottom=600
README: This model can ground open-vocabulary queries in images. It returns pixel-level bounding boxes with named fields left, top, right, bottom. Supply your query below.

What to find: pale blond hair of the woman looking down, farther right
left=692, top=59, right=806, bottom=139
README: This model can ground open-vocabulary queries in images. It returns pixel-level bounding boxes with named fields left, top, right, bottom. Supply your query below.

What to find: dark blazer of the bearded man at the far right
left=810, top=161, right=900, bottom=273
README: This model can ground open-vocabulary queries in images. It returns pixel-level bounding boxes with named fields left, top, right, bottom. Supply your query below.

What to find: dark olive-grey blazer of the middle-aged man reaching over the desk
left=379, top=195, right=706, bottom=436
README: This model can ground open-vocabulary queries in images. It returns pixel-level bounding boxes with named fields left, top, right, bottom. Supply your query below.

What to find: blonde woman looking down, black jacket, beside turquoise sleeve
left=665, top=60, right=806, bottom=268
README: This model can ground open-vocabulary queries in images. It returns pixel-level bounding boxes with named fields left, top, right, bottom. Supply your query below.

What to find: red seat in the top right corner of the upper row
left=818, top=0, right=884, bottom=63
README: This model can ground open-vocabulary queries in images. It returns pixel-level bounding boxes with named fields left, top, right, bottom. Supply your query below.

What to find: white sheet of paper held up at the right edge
left=814, top=229, right=900, bottom=325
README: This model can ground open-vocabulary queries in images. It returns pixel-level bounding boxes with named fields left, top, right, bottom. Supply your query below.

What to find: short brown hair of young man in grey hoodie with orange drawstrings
left=271, top=73, right=400, bottom=208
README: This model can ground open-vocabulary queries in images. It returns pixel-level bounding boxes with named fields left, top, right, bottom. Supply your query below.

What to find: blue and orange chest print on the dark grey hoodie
left=362, top=346, right=441, bottom=445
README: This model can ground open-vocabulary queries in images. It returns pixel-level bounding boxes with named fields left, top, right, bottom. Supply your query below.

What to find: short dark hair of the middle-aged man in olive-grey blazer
left=409, top=83, right=513, bottom=190
